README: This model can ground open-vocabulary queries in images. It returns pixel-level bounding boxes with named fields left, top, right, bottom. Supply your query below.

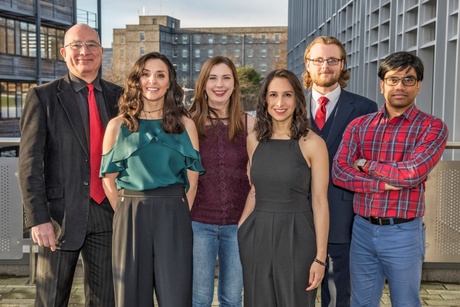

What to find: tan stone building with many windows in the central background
left=112, top=16, right=287, bottom=88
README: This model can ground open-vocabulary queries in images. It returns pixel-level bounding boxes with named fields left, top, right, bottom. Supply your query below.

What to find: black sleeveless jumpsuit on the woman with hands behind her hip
left=238, top=139, right=316, bottom=307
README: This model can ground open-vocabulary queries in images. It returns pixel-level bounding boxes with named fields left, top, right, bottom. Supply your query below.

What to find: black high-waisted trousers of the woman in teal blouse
left=113, top=186, right=193, bottom=307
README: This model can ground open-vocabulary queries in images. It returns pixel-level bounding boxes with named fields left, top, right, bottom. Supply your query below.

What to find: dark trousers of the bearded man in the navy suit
left=321, top=243, right=351, bottom=307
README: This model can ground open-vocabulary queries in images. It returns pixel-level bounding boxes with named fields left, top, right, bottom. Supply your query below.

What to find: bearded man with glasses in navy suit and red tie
left=303, top=36, right=377, bottom=306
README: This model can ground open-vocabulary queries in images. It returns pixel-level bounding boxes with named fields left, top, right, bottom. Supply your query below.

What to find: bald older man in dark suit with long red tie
left=19, top=24, right=122, bottom=307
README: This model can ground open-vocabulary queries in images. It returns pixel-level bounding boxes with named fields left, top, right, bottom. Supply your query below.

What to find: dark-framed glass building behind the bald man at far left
left=0, top=0, right=76, bottom=137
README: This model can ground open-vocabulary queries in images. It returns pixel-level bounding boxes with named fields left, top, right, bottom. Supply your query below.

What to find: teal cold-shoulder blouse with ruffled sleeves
left=100, top=119, right=205, bottom=191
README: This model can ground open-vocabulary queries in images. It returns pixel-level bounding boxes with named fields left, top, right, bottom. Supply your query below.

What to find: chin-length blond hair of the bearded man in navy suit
left=302, top=36, right=350, bottom=90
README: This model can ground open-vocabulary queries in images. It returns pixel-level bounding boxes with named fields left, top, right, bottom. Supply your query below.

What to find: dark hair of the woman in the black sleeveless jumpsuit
left=254, top=69, right=309, bottom=141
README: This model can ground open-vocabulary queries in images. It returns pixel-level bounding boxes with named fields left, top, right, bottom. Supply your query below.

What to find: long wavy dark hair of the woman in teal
left=118, top=52, right=188, bottom=134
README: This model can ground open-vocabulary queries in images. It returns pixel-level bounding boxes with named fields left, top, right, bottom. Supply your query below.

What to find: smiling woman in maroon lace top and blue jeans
left=190, top=56, right=254, bottom=307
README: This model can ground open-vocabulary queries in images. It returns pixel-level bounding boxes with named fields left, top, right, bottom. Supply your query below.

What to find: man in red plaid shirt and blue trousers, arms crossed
left=332, top=52, right=448, bottom=306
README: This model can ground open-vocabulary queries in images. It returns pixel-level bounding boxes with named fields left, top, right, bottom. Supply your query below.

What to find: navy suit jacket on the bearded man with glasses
left=306, top=89, right=377, bottom=243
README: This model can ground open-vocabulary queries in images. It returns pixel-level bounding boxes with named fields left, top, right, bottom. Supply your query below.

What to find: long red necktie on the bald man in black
left=86, top=84, right=105, bottom=204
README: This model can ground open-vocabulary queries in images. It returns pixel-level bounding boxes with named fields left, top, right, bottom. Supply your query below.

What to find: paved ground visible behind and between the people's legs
left=0, top=276, right=460, bottom=307
